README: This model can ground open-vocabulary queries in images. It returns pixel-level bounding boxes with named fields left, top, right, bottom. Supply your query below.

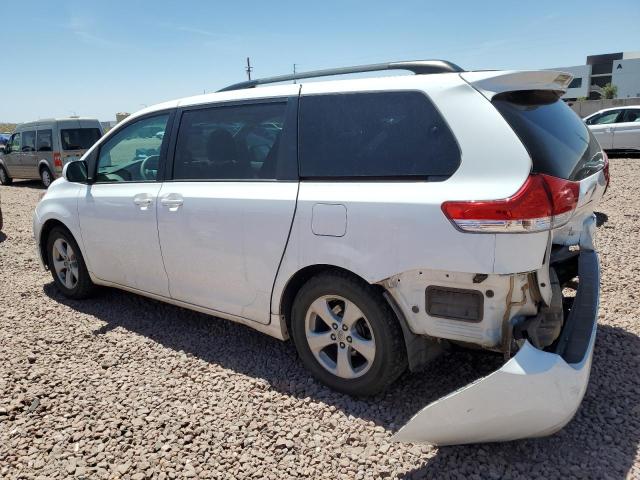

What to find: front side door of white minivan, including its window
left=78, top=113, right=169, bottom=297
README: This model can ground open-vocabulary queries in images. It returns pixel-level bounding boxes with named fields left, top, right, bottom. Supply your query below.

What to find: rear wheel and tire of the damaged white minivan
left=291, top=272, right=407, bottom=396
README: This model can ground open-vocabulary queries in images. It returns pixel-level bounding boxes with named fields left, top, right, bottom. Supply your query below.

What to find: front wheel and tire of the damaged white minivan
left=47, top=227, right=95, bottom=300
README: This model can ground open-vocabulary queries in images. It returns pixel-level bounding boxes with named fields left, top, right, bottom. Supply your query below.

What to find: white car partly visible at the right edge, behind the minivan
left=584, top=105, right=640, bottom=153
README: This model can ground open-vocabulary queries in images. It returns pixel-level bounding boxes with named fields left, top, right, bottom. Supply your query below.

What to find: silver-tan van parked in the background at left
left=0, top=118, right=103, bottom=188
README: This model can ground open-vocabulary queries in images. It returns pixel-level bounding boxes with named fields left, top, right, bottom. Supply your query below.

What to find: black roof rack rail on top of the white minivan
left=218, top=60, right=464, bottom=92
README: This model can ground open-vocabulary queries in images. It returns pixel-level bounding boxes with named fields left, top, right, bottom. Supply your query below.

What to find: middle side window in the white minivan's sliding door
left=173, top=102, right=287, bottom=180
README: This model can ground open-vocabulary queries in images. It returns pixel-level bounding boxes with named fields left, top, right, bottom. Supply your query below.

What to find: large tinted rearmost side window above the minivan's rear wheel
left=300, top=92, right=460, bottom=180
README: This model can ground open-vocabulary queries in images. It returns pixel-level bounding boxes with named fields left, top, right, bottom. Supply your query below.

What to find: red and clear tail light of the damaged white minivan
left=442, top=174, right=580, bottom=233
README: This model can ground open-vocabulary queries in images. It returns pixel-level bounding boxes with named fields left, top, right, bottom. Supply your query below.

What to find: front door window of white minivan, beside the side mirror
left=96, top=113, right=169, bottom=183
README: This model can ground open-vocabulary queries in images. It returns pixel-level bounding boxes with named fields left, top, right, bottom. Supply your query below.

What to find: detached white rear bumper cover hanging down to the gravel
left=392, top=250, right=600, bottom=445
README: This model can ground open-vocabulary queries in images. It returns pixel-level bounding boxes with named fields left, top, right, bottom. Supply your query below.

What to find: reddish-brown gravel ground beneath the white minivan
left=0, top=159, right=640, bottom=479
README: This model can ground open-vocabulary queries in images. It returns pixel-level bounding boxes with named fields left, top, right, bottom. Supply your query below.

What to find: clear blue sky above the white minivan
left=0, top=0, right=640, bottom=122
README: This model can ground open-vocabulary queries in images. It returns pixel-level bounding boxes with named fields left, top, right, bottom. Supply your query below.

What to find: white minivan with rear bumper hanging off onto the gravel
left=34, top=61, right=608, bottom=444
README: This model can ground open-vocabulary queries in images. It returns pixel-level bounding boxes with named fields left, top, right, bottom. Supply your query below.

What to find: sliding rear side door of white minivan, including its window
left=158, top=96, right=298, bottom=324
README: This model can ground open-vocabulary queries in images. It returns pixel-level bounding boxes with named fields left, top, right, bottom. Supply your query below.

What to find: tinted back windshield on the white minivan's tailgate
left=493, top=90, right=604, bottom=181
